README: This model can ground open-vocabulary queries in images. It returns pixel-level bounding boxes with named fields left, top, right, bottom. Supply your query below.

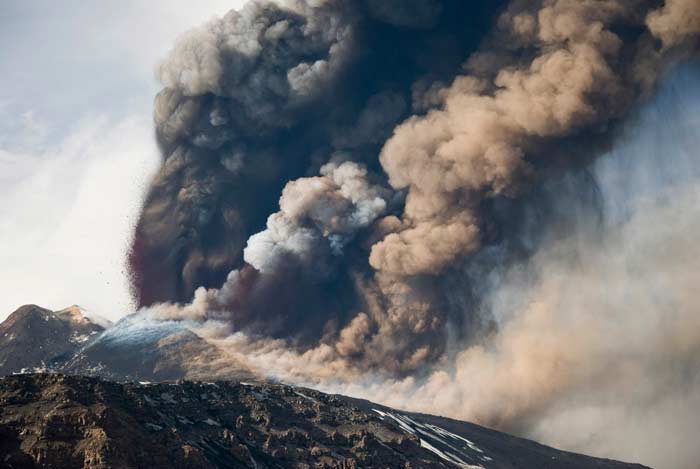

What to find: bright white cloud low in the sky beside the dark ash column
left=0, top=116, right=158, bottom=318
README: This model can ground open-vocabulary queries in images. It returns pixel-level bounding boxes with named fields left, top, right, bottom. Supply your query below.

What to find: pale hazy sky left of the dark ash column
left=0, top=0, right=245, bottom=320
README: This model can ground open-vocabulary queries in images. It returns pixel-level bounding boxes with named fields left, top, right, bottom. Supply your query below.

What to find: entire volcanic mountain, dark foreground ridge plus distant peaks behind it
left=0, top=305, right=656, bottom=469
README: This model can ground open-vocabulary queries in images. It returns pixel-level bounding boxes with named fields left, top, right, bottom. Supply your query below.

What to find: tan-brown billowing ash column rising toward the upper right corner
left=370, top=0, right=697, bottom=275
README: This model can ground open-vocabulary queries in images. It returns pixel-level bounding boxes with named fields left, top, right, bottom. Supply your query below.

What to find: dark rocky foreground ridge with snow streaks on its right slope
left=0, top=374, right=642, bottom=469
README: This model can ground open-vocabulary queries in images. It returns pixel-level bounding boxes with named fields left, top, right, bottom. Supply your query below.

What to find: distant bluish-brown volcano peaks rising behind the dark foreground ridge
left=0, top=305, right=256, bottom=381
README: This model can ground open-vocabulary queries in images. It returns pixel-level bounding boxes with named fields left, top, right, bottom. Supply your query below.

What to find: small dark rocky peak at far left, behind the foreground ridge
left=0, top=305, right=104, bottom=375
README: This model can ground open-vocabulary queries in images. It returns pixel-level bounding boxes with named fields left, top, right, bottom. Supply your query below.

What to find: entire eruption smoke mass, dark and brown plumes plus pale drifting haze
left=131, top=0, right=700, bottom=467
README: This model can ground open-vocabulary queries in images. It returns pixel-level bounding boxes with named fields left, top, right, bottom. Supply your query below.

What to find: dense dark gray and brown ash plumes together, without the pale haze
left=131, top=0, right=698, bottom=373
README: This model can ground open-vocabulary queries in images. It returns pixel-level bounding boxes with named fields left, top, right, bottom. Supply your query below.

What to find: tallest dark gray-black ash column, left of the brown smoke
left=131, top=1, right=499, bottom=305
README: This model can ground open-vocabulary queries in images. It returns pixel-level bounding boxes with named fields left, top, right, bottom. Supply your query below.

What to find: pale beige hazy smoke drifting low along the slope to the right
left=148, top=65, right=700, bottom=468
